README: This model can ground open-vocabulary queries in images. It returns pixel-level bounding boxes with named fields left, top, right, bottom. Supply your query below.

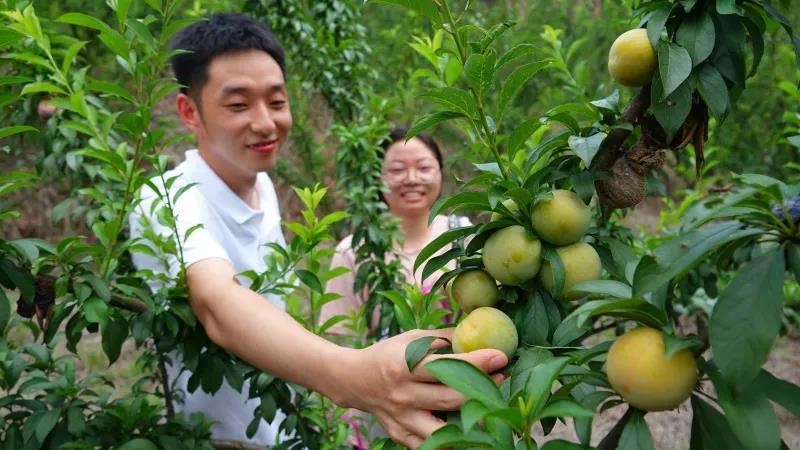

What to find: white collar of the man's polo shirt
left=186, top=150, right=264, bottom=225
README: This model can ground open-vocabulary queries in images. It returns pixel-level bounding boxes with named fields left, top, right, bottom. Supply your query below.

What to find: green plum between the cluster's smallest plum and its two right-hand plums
left=482, top=225, right=542, bottom=286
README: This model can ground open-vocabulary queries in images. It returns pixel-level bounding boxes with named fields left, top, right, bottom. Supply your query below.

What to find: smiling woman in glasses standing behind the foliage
left=320, top=128, right=469, bottom=334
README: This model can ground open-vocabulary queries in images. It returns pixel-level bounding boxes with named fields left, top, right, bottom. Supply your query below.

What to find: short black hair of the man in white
left=170, top=14, right=286, bottom=100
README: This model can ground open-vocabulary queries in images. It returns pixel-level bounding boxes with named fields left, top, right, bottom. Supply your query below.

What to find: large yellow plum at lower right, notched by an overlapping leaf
left=606, top=327, right=697, bottom=411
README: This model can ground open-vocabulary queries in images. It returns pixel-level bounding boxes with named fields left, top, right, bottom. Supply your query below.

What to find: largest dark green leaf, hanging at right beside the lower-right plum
left=709, top=248, right=786, bottom=387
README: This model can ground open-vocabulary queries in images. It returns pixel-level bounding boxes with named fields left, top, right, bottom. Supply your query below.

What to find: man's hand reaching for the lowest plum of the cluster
left=334, top=328, right=508, bottom=449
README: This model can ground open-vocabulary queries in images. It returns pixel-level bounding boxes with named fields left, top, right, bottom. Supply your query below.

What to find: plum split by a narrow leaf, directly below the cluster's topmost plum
left=539, top=242, right=603, bottom=300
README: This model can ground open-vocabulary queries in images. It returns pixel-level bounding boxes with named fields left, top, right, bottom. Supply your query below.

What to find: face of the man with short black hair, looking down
left=178, top=50, right=292, bottom=185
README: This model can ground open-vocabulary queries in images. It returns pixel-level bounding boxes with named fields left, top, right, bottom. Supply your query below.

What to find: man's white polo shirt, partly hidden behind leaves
left=129, top=150, right=286, bottom=445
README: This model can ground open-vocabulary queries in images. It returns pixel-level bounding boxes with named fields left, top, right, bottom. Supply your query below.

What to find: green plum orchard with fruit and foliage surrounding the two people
left=0, top=0, right=800, bottom=450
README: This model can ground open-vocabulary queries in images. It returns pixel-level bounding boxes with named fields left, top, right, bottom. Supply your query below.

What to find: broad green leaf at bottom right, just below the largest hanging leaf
left=708, top=368, right=781, bottom=450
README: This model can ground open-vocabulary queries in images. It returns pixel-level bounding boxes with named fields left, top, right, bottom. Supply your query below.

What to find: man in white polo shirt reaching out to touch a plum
left=131, top=14, right=507, bottom=448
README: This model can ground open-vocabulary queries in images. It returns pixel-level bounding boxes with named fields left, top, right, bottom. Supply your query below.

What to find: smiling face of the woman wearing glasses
left=383, top=138, right=442, bottom=217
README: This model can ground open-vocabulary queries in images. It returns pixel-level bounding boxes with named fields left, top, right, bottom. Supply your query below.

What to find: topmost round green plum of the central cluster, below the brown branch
left=531, top=189, right=592, bottom=245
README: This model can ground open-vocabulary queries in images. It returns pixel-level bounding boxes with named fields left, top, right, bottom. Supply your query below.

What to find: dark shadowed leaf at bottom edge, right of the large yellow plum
left=689, top=395, right=742, bottom=450
